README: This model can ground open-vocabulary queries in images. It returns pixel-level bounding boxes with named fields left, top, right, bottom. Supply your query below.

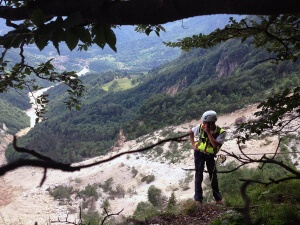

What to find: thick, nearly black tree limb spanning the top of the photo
left=0, top=0, right=300, bottom=25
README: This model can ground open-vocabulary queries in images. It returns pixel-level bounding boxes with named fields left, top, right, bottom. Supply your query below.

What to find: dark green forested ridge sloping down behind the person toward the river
left=6, top=35, right=300, bottom=162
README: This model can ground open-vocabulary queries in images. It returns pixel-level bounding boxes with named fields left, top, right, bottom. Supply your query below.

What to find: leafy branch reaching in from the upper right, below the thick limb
left=165, top=14, right=300, bottom=62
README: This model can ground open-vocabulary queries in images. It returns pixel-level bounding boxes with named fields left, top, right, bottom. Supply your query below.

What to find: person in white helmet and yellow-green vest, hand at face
left=190, top=110, right=226, bottom=205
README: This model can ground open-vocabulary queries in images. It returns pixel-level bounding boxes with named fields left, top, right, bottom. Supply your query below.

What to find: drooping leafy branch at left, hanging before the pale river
left=0, top=59, right=84, bottom=120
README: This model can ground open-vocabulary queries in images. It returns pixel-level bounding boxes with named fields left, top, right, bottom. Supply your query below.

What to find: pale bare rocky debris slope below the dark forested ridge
left=0, top=105, right=298, bottom=225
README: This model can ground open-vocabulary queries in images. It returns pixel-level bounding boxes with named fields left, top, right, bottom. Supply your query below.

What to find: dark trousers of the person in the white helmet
left=194, top=151, right=222, bottom=201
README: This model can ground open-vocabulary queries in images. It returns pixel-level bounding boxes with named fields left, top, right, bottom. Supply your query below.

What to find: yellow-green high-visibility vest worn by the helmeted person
left=196, top=125, right=225, bottom=154
